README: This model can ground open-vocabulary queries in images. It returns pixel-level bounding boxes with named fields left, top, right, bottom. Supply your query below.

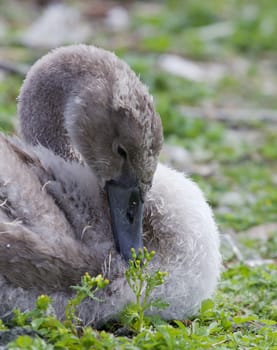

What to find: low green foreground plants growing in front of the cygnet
left=5, top=264, right=277, bottom=350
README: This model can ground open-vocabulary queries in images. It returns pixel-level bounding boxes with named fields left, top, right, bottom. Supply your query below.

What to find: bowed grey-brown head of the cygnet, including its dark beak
left=65, top=45, right=163, bottom=260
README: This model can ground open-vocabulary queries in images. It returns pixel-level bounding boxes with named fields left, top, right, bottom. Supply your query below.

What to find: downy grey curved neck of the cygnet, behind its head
left=18, top=47, right=112, bottom=159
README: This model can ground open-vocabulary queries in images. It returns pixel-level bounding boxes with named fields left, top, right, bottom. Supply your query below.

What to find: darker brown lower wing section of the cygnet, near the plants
left=0, top=222, right=101, bottom=293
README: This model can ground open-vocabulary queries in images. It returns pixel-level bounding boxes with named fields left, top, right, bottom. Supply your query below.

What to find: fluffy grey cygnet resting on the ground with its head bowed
left=0, top=45, right=221, bottom=326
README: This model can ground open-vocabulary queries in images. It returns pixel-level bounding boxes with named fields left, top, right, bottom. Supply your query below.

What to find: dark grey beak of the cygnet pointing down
left=106, top=180, right=143, bottom=261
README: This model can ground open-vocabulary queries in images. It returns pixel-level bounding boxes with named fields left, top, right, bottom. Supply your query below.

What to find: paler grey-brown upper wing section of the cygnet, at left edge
left=0, top=135, right=74, bottom=241
